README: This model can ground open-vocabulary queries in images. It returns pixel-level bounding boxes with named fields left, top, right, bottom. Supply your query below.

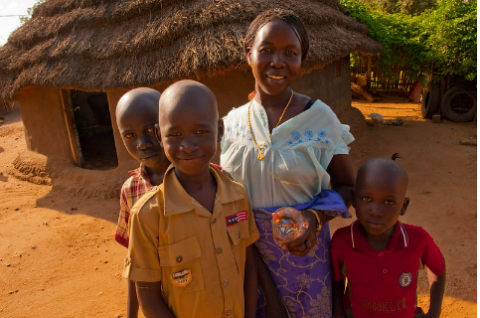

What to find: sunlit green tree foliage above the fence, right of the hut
left=340, top=0, right=477, bottom=80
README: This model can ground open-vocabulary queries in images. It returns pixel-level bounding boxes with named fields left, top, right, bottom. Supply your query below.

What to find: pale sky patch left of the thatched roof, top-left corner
left=0, top=0, right=36, bottom=45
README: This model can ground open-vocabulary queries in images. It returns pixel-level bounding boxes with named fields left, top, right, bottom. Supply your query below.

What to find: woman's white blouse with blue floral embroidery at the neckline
left=220, top=100, right=355, bottom=209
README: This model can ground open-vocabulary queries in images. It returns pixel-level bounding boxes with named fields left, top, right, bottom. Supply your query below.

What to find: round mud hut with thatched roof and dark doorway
left=0, top=0, right=382, bottom=196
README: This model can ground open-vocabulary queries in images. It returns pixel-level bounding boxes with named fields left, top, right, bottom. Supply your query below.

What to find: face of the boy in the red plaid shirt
left=117, top=106, right=165, bottom=168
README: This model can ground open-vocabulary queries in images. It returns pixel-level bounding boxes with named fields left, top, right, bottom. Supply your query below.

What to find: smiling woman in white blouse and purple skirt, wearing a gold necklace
left=221, top=9, right=354, bottom=317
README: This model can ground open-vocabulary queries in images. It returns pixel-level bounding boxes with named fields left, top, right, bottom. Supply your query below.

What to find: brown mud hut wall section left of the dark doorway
left=18, top=86, right=73, bottom=160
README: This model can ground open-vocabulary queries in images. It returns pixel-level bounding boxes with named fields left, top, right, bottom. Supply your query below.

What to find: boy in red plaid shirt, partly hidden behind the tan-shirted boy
left=115, top=87, right=170, bottom=317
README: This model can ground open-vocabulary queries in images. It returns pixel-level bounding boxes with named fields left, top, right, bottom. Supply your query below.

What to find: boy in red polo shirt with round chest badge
left=331, top=158, right=445, bottom=318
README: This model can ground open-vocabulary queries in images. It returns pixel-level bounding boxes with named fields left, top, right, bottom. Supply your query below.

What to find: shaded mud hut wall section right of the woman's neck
left=292, top=56, right=352, bottom=116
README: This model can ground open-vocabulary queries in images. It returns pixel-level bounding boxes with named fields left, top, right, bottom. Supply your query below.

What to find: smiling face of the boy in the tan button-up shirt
left=159, top=95, right=223, bottom=176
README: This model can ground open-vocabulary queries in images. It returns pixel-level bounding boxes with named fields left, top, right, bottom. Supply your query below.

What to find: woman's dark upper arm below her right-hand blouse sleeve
left=327, top=155, right=355, bottom=208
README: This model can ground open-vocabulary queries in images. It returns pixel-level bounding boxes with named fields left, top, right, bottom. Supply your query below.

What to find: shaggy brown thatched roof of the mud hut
left=0, top=0, right=382, bottom=99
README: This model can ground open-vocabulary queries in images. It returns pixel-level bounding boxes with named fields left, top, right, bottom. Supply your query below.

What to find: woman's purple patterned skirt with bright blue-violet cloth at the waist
left=253, top=190, right=352, bottom=318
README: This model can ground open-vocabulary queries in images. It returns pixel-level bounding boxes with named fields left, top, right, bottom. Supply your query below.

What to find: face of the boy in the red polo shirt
left=354, top=174, right=409, bottom=239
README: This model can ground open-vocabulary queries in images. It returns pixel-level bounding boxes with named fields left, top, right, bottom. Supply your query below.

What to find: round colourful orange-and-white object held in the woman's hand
left=272, top=207, right=307, bottom=245
